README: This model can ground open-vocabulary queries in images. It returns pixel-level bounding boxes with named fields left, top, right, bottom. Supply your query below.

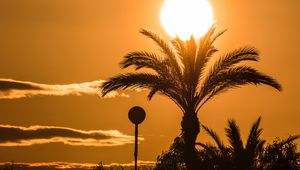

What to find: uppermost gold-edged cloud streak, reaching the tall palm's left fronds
left=0, top=79, right=128, bottom=99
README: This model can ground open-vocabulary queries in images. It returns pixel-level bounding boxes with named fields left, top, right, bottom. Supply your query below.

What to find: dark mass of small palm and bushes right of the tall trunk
left=197, top=118, right=300, bottom=170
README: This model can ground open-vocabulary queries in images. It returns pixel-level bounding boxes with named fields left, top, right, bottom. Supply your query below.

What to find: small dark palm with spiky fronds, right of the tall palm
left=197, top=118, right=265, bottom=170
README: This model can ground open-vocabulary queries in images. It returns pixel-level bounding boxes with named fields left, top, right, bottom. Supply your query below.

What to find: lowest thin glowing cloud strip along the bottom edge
left=0, top=161, right=155, bottom=170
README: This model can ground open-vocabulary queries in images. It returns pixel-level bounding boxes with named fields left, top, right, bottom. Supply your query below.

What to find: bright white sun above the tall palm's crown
left=160, top=0, right=214, bottom=40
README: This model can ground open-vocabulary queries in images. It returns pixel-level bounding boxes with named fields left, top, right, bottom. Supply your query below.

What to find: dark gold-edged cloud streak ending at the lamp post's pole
left=0, top=125, right=143, bottom=147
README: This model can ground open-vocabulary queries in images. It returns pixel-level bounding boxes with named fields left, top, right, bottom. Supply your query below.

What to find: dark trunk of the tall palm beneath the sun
left=181, top=111, right=200, bottom=170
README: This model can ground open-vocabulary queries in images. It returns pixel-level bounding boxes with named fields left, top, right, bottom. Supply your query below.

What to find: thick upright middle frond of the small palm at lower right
left=225, top=120, right=244, bottom=153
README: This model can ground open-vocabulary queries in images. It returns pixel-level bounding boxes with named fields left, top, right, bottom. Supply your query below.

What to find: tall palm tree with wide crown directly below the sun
left=101, top=26, right=281, bottom=169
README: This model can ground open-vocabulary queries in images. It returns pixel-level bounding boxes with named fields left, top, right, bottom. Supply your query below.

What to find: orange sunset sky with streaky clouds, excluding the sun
left=0, top=0, right=300, bottom=167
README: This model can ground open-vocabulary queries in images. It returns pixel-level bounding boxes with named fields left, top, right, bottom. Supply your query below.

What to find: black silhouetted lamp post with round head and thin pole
left=128, top=106, right=146, bottom=170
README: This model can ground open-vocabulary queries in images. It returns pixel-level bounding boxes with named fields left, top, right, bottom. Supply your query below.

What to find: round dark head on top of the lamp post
left=128, top=106, right=146, bottom=125
